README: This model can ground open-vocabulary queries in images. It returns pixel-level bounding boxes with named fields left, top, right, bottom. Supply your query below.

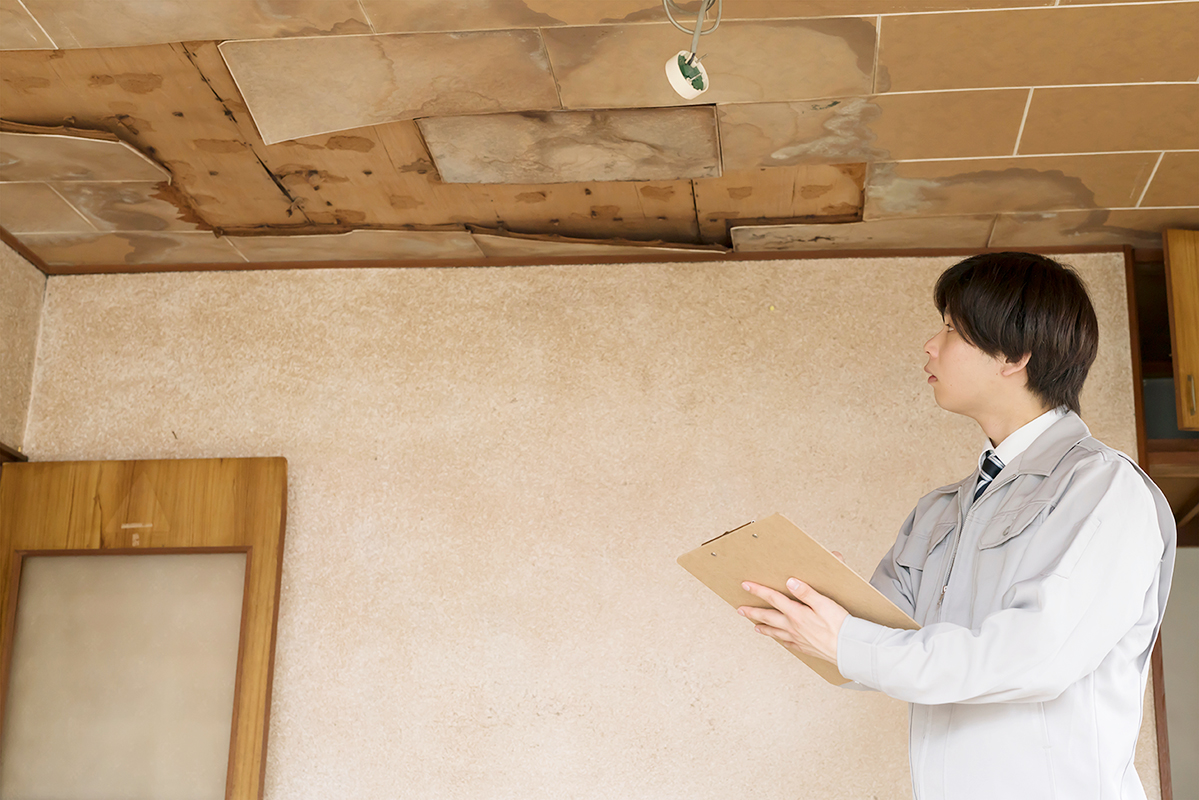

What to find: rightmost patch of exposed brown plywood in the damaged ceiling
left=694, top=164, right=866, bottom=242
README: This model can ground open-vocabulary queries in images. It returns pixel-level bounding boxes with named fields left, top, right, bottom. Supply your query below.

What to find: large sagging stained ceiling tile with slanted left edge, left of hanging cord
left=221, top=30, right=559, bottom=144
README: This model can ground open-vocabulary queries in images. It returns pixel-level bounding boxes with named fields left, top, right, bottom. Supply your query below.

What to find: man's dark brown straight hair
left=933, top=253, right=1099, bottom=414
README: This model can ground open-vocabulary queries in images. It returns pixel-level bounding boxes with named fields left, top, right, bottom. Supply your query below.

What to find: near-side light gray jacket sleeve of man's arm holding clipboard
left=837, top=458, right=1165, bottom=704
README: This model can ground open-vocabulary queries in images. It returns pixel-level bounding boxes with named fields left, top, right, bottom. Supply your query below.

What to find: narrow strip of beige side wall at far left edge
left=0, top=242, right=46, bottom=450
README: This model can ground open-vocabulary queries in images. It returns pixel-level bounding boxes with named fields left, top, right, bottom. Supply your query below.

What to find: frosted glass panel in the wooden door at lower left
left=0, top=553, right=246, bottom=800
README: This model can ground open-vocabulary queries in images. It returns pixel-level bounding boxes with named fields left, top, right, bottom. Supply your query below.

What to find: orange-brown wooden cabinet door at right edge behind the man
left=1164, top=230, right=1199, bottom=431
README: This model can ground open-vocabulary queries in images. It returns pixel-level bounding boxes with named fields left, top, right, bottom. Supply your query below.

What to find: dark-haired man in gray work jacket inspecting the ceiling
left=739, top=253, right=1175, bottom=800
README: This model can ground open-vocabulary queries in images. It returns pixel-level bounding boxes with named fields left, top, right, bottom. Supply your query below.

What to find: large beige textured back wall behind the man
left=26, top=254, right=1157, bottom=800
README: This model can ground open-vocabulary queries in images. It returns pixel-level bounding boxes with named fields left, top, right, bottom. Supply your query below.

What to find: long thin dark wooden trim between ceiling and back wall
left=32, top=245, right=1128, bottom=275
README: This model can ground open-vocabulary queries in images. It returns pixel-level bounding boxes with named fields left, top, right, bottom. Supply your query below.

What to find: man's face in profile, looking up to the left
left=924, top=314, right=1005, bottom=417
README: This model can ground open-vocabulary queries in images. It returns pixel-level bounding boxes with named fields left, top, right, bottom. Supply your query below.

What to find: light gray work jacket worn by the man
left=837, top=411, right=1175, bottom=800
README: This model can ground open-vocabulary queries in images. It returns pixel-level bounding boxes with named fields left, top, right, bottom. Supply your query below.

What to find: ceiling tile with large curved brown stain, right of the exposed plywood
left=864, top=152, right=1158, bottom=219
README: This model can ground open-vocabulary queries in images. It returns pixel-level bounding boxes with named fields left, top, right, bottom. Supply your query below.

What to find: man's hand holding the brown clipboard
left=737, top=573, right=849, bottom=663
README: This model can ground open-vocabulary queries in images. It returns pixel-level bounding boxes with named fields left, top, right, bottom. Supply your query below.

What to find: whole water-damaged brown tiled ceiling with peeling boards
left=0, top=0, right=1199, bottom=270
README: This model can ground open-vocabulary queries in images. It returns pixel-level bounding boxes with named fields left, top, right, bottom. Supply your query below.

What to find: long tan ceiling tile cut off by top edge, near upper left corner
left=15, top=0, right=370, bottom=49
